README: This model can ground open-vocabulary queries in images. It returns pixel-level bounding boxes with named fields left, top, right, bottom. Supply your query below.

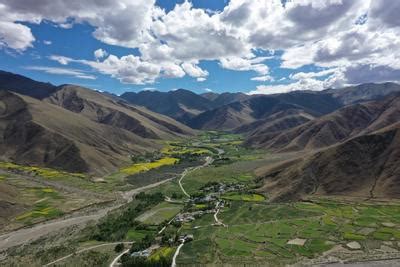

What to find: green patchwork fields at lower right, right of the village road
left=178, top=200, right=400, bottom=265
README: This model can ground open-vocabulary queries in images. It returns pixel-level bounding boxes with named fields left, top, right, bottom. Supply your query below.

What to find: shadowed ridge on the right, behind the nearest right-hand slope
left=247, top=92, right=400, bottom=151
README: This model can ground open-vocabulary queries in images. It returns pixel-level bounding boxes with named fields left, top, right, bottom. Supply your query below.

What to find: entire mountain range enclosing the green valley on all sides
left=0, top=72, right=400, bottom=200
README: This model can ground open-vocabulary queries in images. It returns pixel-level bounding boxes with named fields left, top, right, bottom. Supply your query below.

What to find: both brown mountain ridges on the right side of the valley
left=255, top=93, right=400, bottom=200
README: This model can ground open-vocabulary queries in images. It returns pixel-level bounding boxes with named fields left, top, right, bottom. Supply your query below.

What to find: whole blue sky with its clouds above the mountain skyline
left=0, top=0, right=400, bottom=94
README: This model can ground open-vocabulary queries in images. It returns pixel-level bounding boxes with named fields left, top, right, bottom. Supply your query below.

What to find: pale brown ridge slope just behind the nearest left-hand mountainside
left=44, top=85, right=194, bottom=139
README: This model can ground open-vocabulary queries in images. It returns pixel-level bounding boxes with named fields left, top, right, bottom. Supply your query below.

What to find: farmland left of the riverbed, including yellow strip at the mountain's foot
left=0, top=162, right=119, bottom=231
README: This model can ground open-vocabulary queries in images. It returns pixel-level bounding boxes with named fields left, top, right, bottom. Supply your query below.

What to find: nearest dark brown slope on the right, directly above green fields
left=259, top=124, right=400, bottom=201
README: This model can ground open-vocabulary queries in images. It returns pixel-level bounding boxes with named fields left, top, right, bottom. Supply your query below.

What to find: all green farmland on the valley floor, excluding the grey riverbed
left=0, top=132, right=400, bottom=266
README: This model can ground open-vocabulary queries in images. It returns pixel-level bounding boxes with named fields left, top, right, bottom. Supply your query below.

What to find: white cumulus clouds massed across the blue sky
left=0, top=0, right=400, bottom=93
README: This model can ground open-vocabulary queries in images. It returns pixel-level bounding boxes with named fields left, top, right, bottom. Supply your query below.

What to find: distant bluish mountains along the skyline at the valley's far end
left=121, top=83, right=400, bottom=133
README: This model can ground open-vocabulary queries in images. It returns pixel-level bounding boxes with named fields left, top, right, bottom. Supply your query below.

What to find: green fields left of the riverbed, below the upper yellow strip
left=0, top=174, right=111, bottom=230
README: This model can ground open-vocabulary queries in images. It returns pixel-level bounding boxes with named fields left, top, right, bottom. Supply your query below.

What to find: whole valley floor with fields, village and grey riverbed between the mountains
left=0, top=132, right=400, bottom=266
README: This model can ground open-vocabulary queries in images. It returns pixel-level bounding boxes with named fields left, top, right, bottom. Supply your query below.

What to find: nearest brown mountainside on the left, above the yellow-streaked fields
left=0, top=91, right=158, bottom=174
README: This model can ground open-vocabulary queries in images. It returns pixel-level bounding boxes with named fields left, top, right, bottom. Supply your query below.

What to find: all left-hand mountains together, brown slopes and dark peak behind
left=0, top=72, right=195, bottom=174
